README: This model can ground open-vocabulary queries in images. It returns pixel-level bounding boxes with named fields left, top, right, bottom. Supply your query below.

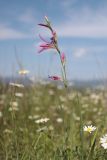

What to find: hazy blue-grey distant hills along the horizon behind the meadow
left=0, top=77, right=107, bottom=88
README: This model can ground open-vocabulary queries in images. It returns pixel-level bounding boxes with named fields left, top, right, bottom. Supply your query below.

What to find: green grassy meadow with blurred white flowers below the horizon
left=0, top=84, right=107, bottom=160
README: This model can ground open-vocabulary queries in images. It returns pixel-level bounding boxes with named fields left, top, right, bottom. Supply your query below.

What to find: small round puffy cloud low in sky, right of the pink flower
left=73, top=48, right=87, bottom=58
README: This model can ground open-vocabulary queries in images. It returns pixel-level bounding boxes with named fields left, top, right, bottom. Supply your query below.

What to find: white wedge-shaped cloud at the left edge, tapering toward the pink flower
left=0, top=24, right=30, bottom=40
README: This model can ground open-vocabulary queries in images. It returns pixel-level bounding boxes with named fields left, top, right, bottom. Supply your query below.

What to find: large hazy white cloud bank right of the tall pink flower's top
left=56, top=7, right=107, bottom=38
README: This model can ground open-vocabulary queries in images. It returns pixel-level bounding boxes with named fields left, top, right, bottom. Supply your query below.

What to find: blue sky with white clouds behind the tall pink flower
left=0, top=0, right=107, bottom=80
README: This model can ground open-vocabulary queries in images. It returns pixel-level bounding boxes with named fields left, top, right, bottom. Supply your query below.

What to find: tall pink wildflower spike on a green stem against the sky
left=39, top=16, right=67, bottom=87
